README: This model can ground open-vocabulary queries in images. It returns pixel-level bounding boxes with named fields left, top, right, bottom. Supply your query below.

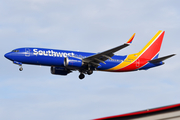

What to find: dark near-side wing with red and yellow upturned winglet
left=82, top=33, right=135, bottom=67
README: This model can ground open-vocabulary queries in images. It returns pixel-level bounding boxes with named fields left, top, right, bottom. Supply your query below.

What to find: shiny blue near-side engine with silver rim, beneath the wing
left=64, top=57, right=83, bottom=68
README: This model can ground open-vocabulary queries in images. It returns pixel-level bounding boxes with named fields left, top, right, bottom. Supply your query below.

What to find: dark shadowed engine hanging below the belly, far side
left=51, top=66, right=71, bottom=75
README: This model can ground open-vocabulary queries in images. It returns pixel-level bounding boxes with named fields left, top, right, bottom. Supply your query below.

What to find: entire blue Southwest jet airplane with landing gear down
left=4, top=30, right=175, bottom=79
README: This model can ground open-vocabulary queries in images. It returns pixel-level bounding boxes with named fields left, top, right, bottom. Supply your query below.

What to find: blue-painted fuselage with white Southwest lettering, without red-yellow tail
left=5, top=48, right=127, bottom=70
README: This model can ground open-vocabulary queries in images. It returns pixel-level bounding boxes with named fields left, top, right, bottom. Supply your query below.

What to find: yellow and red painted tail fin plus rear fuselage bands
left=113, top=30, right=165, bottom=72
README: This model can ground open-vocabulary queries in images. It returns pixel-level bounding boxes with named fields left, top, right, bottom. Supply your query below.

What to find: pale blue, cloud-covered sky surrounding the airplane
left=0, top=0, right=180, bottom=120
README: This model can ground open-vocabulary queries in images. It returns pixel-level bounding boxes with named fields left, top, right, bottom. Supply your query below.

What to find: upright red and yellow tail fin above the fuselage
left=138, top=30, right=165, bottom=60
